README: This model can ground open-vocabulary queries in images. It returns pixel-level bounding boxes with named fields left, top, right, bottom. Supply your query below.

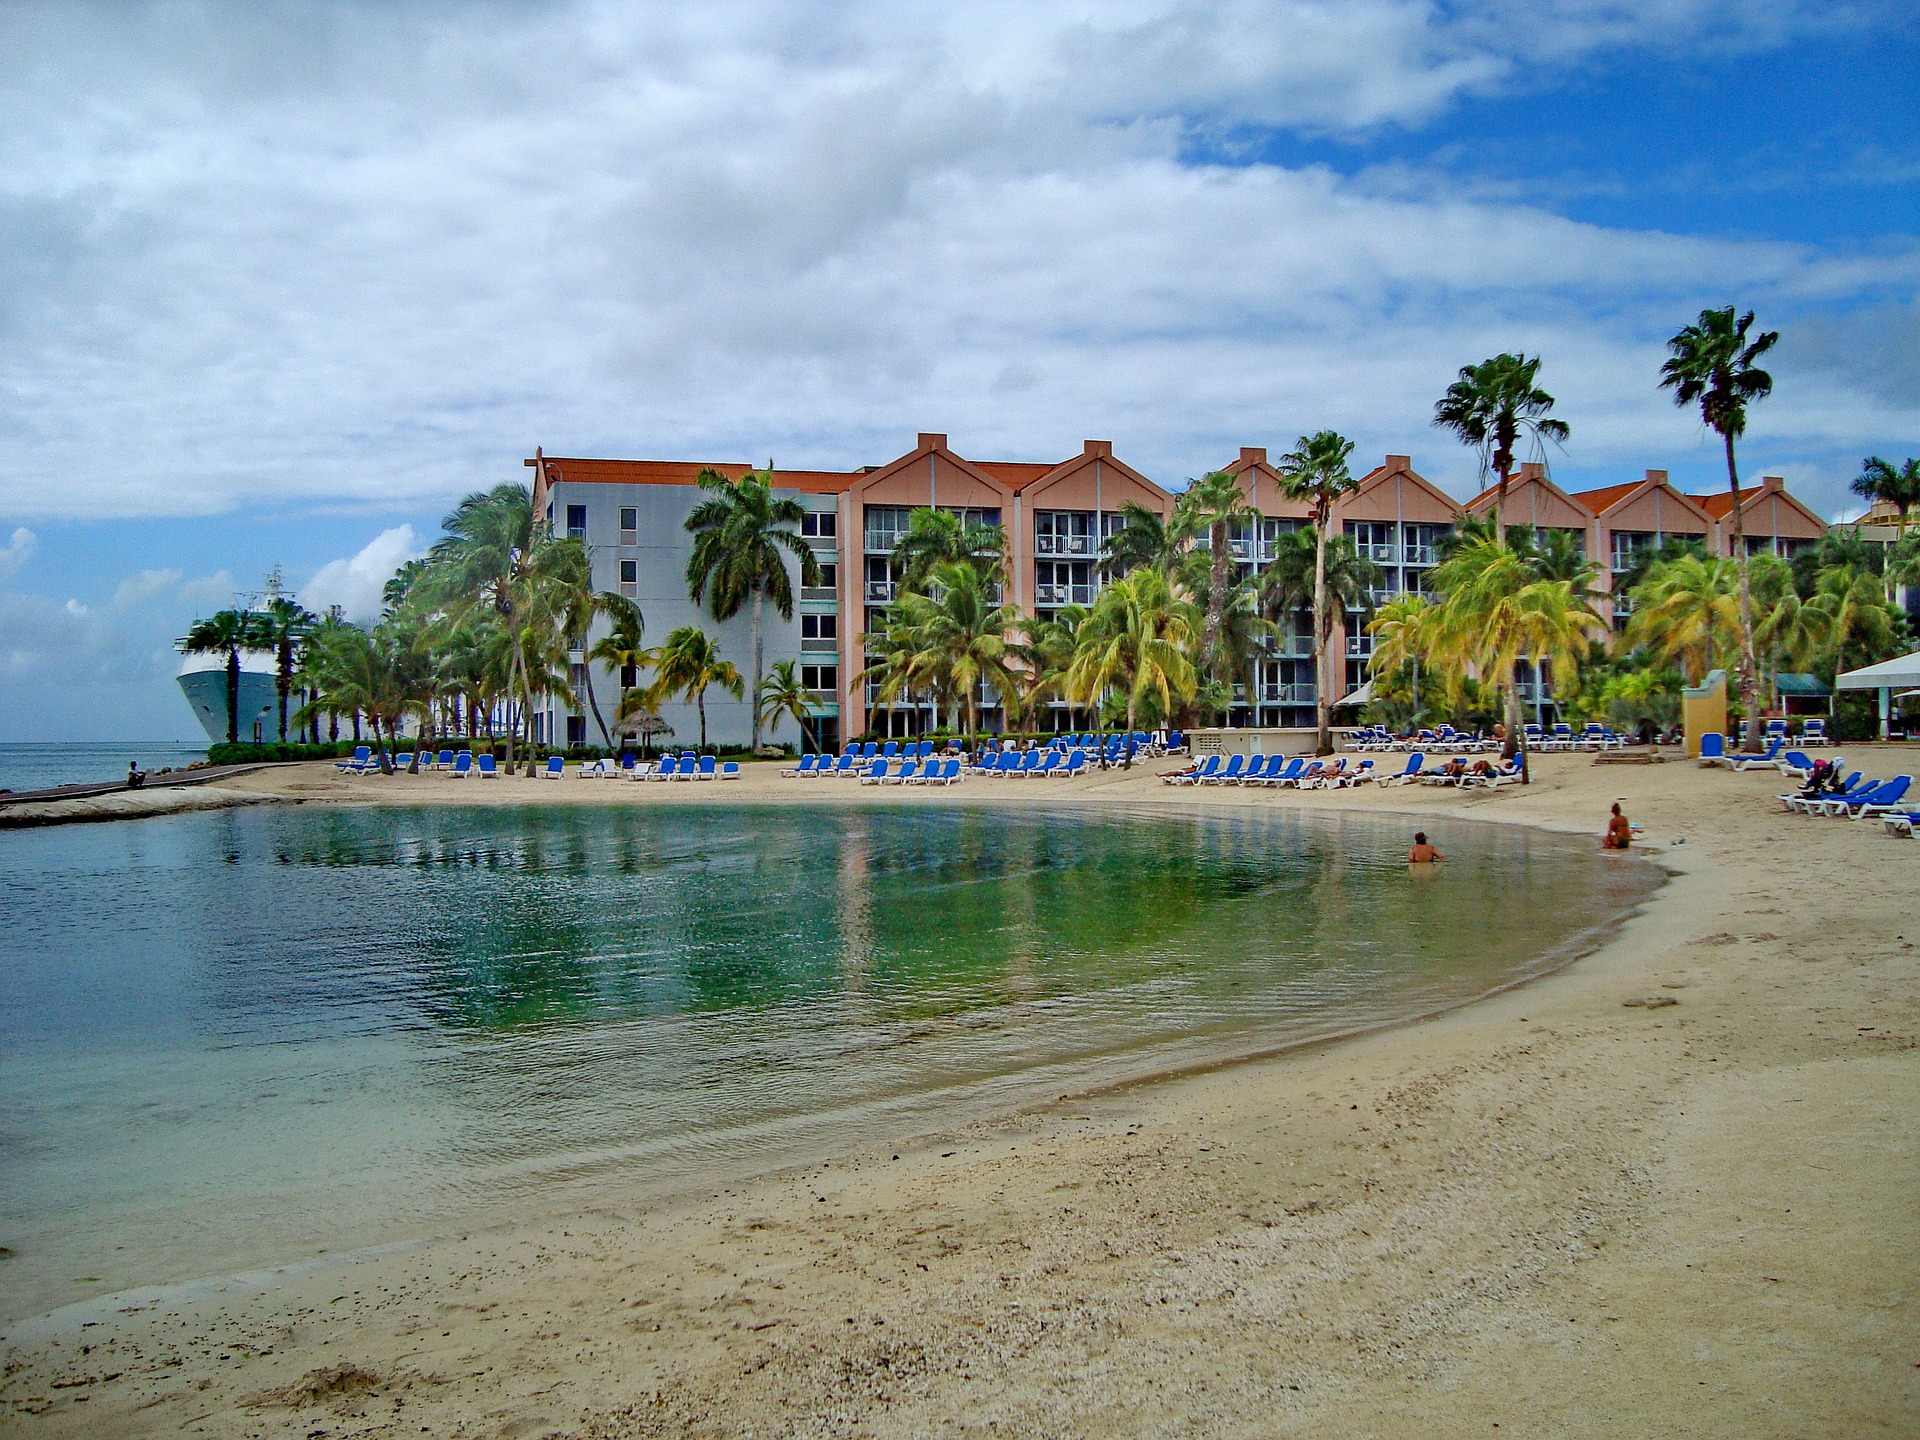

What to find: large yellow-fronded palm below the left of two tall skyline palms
left=1434, top=540, right=1601, bottom=781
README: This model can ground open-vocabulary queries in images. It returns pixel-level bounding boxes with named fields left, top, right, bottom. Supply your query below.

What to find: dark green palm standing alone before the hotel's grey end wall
left=674, top=470, right=820, bottom=749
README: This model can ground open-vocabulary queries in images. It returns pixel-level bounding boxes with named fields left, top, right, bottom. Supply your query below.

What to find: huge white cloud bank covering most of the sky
left=0, top=0, right=1920, bottom=529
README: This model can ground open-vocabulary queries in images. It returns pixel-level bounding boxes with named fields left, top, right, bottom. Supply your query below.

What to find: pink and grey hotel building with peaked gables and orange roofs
left=526, top=434, right=1826, bottom=747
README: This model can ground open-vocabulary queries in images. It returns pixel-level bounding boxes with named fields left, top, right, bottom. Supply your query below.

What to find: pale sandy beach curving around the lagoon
left=0, top=747, right=1920, bottom=1440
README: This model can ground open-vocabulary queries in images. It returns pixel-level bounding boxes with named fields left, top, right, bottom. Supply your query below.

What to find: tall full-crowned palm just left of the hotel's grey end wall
left=424, top=482, right=589, bottom=776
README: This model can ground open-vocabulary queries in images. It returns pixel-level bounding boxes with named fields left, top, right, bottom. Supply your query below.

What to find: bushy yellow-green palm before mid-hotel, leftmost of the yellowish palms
left=1066, top=568, right=1200, bottom=733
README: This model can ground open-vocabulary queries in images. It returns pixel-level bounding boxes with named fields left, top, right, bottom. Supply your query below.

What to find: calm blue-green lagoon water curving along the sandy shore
left=0, top=804, right=1653, bottom=1315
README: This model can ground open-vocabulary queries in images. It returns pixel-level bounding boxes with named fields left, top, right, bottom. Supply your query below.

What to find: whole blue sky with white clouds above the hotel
left=0, top=0, right=1920, bottom=741
